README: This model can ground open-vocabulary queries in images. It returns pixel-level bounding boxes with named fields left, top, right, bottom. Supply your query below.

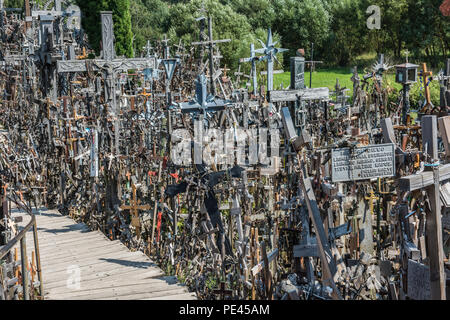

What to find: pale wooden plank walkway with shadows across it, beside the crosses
left=12, top=210, right=195, bottom=300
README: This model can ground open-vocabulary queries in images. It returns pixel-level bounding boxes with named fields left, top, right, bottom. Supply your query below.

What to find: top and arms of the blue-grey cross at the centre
left=173, top=74, right=232, bottom=115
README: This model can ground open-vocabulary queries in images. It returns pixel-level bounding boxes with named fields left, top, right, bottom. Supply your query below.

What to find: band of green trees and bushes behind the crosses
left=5, top=0, right=450, bottom=68
